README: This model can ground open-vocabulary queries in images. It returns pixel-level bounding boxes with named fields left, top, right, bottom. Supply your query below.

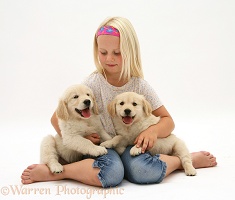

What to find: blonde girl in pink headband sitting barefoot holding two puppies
left=21, top=17, right=217, bottom=187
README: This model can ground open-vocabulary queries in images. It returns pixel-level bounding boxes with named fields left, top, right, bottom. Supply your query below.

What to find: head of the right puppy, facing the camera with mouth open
left=108, top=92, right=152, bottom=126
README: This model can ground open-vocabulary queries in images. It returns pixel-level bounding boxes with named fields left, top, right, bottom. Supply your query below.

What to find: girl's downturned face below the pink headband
left=97, top=35, right=122, bottom=77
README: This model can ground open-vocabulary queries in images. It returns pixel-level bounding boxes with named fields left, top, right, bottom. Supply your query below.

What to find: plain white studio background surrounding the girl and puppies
left=0, top=0, right=235, bottom=199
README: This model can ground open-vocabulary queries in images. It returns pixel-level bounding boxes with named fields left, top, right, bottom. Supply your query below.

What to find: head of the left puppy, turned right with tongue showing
left=57, top=85, right=98, bottom=120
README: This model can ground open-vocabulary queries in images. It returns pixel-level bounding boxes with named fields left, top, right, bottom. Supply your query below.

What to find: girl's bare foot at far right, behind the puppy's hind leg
left=191, top=151, right=217, bottom=169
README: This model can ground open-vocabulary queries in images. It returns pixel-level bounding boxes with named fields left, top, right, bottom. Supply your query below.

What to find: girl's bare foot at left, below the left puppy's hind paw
left=21, top=164, right=63, bottom=184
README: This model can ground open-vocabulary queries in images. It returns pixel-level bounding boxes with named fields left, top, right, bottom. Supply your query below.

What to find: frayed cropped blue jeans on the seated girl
left=93, top=146, right=166, bottom=188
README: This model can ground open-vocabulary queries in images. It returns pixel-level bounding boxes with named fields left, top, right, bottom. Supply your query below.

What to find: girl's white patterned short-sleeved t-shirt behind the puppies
left=83, top=72, right=162, bottom=137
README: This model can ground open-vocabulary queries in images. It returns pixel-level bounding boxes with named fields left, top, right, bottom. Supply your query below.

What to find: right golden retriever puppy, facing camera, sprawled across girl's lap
left=100, top=92, right=196, bottom=176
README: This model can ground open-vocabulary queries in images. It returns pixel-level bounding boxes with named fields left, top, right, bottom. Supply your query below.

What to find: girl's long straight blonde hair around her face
left=93, top=17, right=144, bottom=80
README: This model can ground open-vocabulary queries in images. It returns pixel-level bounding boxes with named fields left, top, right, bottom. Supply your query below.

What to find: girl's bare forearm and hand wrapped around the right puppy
left=135, top=106, right=175, bottom=153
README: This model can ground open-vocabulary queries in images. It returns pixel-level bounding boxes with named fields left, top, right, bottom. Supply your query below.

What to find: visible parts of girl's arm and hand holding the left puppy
left=51, top=112, right=100, bottom=144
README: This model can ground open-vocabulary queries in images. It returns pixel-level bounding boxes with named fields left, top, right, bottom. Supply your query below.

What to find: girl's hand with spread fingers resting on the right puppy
left=134, top=127, right=157, bottom=153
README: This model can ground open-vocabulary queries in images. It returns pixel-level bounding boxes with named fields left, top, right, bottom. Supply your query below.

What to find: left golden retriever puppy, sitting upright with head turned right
left=40, top=84, right=112, bottom=173
